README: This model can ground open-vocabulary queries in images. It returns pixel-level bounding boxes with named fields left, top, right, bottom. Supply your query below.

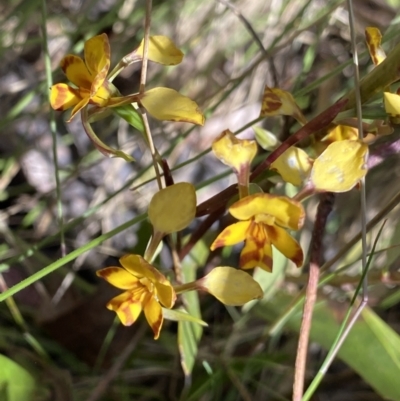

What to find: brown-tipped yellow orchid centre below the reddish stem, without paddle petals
left=210, top=193, right=305, bottom=272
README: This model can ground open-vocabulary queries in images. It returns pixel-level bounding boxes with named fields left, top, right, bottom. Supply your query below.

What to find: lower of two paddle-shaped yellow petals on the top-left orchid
left=140, top=88, right=204, bottom=125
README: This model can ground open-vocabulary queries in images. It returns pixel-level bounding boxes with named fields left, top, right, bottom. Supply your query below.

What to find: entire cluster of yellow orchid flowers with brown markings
left=51, top=25, right=390, bottom=339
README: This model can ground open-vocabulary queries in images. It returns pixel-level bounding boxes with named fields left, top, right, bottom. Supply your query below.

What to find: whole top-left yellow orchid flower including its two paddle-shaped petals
left=50, top=33, right=204, bottom=125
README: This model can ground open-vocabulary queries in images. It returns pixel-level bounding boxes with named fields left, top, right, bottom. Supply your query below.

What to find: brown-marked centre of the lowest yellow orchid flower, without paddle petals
left=96, top=255, right=176, bottom=340
